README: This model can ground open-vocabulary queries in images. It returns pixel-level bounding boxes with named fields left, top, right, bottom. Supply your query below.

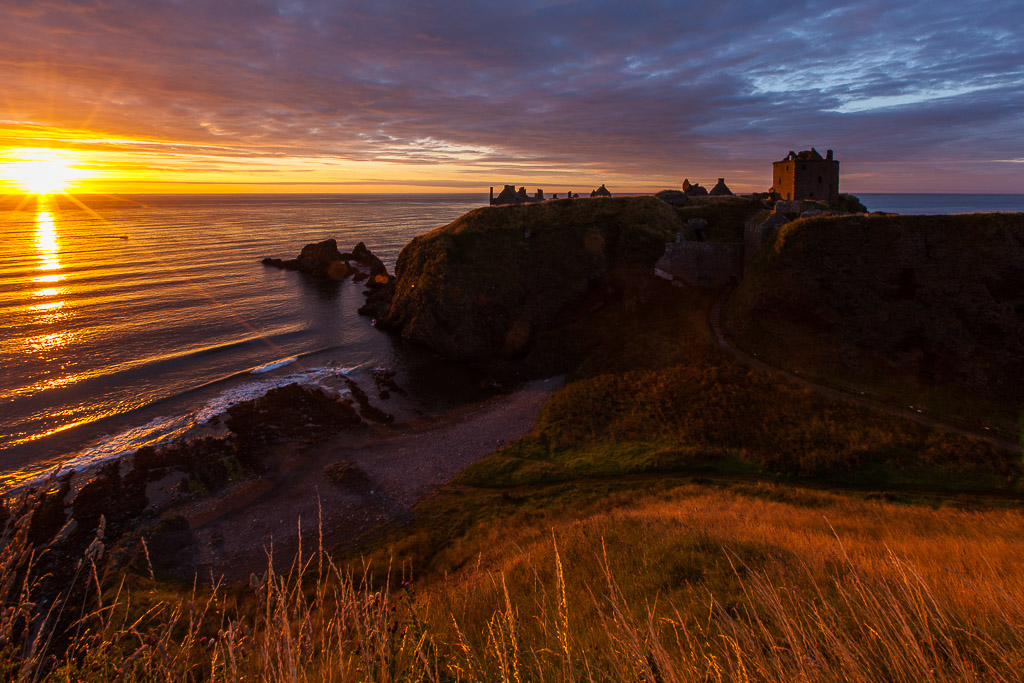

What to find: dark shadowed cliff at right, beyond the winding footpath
left=727, top=214, right=1024, bottom=401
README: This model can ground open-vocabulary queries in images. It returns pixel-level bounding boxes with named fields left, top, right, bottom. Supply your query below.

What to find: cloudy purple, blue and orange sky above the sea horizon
left=0, top=0, right=1024, bottom=195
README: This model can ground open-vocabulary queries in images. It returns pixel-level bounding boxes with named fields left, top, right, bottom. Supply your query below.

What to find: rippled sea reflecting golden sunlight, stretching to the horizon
left=0, top=194, right=1024, bottom=492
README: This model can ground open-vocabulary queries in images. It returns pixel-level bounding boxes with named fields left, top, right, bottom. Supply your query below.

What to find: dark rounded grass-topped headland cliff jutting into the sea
left=377, top=197, right=681, bottom=359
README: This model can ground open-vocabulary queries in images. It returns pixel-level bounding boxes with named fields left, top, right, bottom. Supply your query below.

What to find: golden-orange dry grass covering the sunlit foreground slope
left=6, top=484, right=1024, bottom=681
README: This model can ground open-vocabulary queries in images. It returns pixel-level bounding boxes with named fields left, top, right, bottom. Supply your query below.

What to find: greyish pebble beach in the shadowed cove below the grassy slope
left=167, top=378, right=561, bottom=582
